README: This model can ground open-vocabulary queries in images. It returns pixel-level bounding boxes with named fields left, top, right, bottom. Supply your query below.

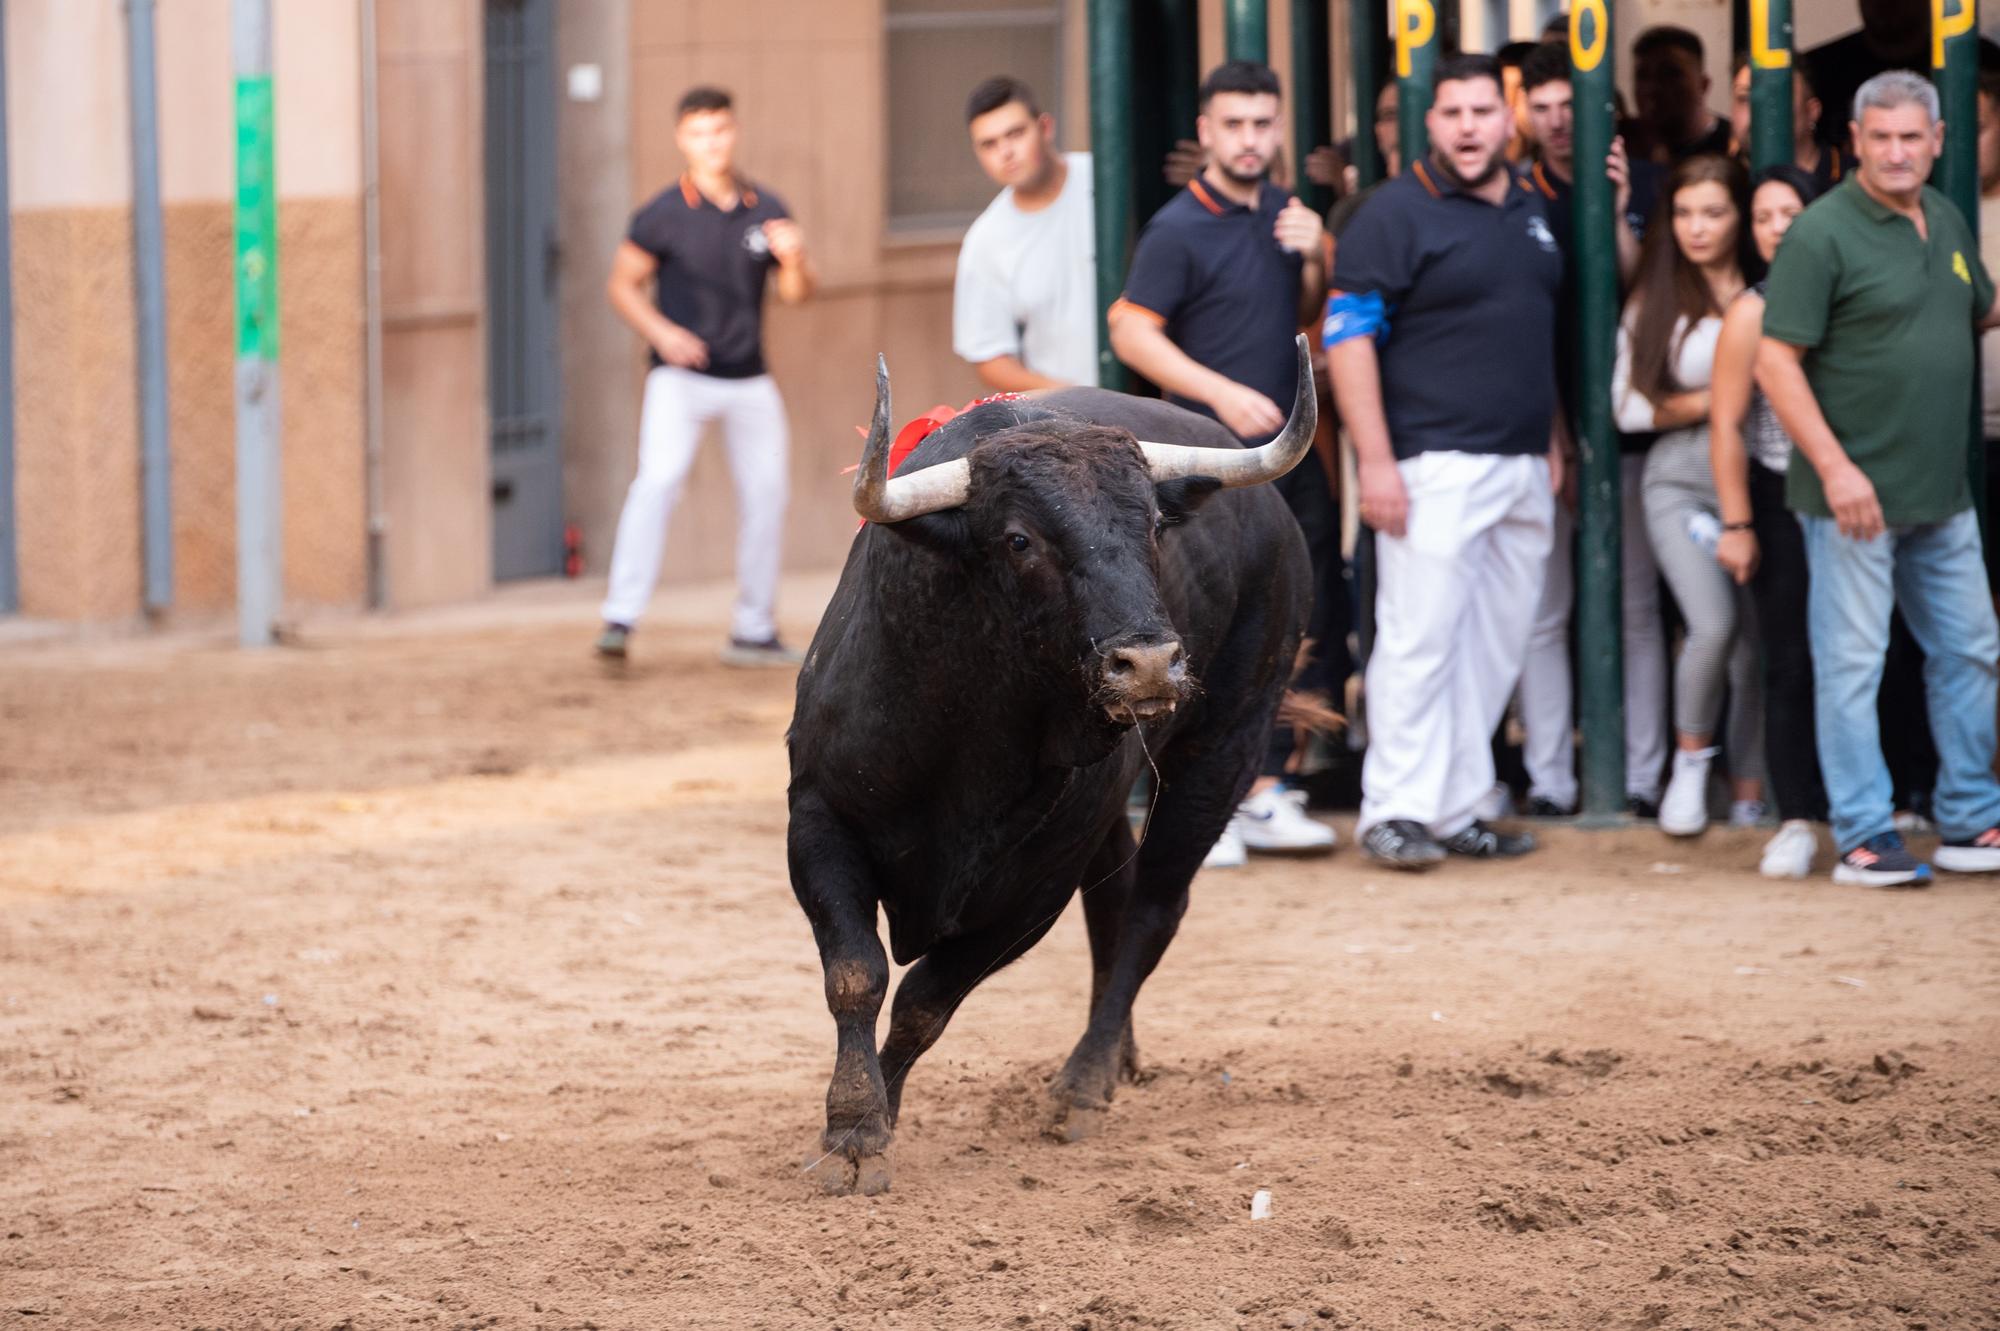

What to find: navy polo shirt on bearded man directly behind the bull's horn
left=1114, top=176, right=1306, bottom=435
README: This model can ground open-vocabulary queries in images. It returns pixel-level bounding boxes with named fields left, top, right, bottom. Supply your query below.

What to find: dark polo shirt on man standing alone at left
left=626, top=176, right=790, bottom=380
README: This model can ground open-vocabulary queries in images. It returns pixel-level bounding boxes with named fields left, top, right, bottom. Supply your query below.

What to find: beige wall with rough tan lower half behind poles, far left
left=6, top=0, right=364, bottom=620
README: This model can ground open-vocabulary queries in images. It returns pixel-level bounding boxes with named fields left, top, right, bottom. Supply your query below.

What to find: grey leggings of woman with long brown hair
left=1640, top=426, right=1764, bottom=781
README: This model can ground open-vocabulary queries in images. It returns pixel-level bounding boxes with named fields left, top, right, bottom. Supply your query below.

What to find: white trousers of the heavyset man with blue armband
left=1358, top=454, right=1556, bottom=837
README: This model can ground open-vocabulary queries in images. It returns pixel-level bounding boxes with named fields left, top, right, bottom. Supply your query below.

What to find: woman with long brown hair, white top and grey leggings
left=1612, top=154, right=1764, bottom=835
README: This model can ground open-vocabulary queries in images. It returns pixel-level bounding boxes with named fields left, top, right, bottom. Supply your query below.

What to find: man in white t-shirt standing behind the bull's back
left=952, top=74, right=1098, bottom=392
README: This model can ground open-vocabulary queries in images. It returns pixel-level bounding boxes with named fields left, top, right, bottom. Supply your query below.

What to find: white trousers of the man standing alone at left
left=604, top=366, right=790, bottom=642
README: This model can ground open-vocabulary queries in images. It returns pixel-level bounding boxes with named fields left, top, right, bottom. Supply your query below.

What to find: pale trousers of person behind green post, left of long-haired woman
left=1520, top=454, right=1666, bottom=807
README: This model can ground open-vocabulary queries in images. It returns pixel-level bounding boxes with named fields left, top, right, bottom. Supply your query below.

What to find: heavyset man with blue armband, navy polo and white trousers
left=1324, top=56, right=1564, bottom=869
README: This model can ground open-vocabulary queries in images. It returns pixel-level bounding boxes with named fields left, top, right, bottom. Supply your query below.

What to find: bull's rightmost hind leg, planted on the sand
left=1050, top=725, right=1264, bottom=1141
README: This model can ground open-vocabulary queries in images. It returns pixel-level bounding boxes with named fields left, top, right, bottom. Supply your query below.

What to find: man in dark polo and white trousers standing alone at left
left=598, top=88, right=812, bottom=666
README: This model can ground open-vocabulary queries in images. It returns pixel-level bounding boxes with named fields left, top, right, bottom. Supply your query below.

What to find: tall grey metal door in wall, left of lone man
left=486, top=0, right=562, bottom=578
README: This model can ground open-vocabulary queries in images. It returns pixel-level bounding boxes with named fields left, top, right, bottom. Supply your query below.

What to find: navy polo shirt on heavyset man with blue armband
left=1334, top=162, right=1562, bottom=460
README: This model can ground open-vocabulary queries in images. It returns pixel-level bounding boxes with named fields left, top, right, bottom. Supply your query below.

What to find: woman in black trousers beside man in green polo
left=1708, top=166, right=1826, bottom=877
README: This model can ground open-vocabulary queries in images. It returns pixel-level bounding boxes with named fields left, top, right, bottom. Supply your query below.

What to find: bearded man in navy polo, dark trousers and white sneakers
left=1110, top=60, right=1348, bottom=867
